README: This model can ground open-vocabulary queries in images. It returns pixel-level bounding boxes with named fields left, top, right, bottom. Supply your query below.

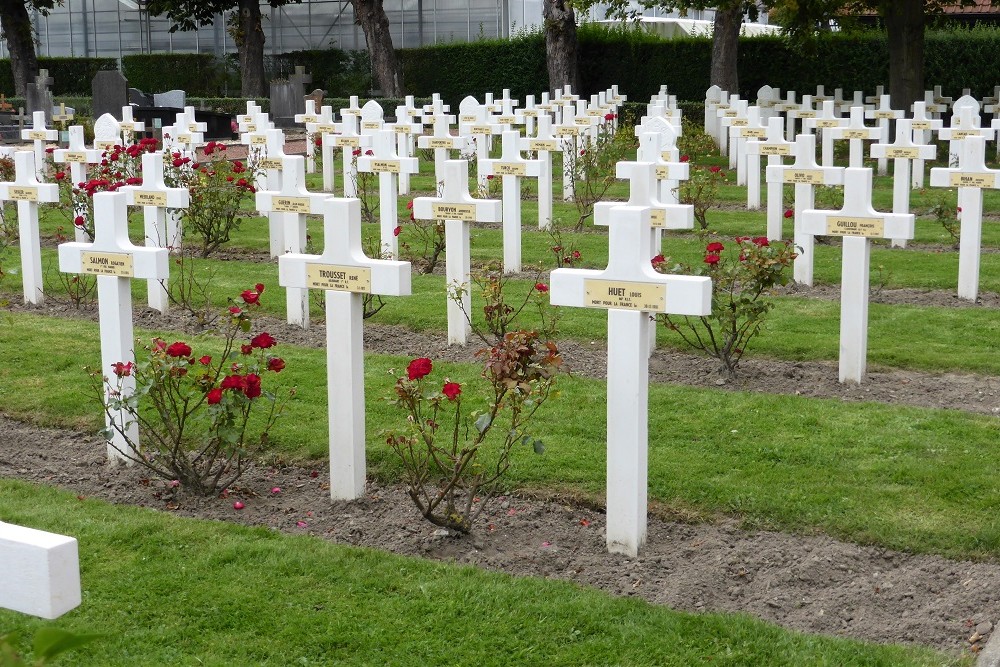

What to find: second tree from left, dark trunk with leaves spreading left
left=144, top=0, right=301, bottom=97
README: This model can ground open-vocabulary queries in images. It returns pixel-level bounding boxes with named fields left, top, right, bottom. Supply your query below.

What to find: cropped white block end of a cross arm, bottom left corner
left=0, top=521, right=82, bottom=619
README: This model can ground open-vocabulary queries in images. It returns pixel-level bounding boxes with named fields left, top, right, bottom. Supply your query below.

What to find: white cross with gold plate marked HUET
left=549, top=206, right=712, bottom=556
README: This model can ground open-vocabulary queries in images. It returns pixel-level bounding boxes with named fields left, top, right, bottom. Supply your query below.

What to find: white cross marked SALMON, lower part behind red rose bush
left=59, top=192, right=170, bottom=464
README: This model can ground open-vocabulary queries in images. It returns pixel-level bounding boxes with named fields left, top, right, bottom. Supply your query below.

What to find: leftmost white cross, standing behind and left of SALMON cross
left=0, top=151, right=59, bottom=305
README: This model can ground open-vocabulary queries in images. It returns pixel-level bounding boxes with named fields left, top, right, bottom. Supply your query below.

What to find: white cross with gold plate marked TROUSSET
left=278, top=197, right=411, bottom=500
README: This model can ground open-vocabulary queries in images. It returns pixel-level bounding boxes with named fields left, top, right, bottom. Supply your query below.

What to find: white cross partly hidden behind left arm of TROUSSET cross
left=256, top=155, right=330, bottom=329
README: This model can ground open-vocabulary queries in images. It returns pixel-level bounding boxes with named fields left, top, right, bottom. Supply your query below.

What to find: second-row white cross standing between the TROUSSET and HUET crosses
left=413, top=160, right=502, bottom=345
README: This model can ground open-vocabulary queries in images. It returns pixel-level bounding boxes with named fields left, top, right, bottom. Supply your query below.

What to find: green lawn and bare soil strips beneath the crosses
left=0, top=138, right=1000, bottom=665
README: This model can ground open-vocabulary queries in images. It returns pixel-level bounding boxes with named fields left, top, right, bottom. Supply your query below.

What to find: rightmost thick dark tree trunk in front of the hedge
left=882, top=0, right=924, bottom=110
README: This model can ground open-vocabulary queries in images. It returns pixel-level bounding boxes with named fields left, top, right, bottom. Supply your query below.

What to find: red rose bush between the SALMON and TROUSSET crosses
left=91, top=284, right=291, bottom=495
